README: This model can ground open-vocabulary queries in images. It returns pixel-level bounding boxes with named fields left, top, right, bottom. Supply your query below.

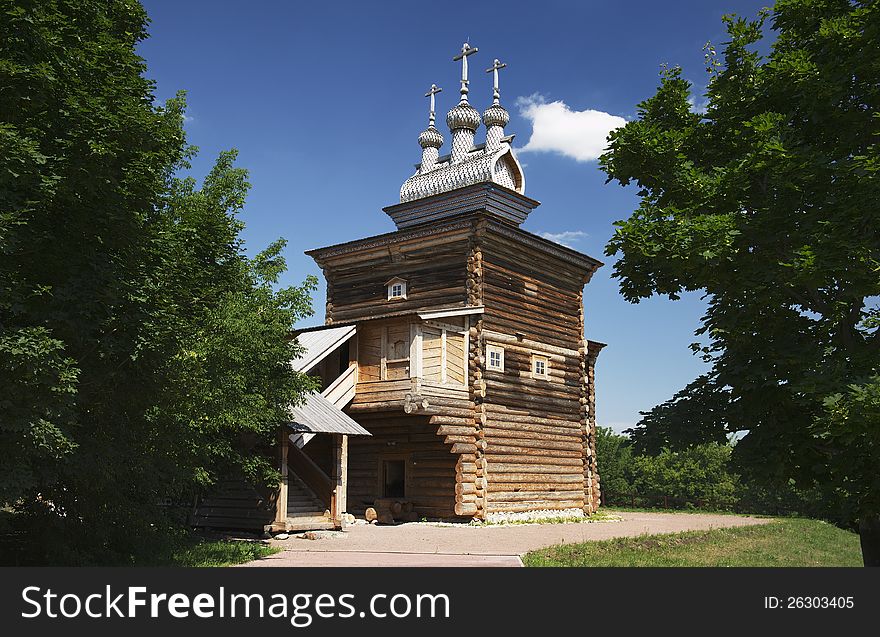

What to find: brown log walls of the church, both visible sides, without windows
left=316, top=214, right=599, bottom=518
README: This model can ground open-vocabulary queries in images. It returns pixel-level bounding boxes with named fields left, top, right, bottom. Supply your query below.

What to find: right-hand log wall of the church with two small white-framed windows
left=475, top=232, right=592, bottom=513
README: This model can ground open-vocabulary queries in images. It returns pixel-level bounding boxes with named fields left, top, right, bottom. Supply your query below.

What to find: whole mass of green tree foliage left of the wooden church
left=0, top=0, right=315, bottom=561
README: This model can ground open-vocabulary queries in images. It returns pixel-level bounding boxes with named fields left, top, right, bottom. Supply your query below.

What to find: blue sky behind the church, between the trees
left=140, top=0, right=767, bottom=430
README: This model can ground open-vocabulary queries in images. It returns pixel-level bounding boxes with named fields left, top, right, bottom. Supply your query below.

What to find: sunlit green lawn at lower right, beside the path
left=523, top=518, right=862, bottom=566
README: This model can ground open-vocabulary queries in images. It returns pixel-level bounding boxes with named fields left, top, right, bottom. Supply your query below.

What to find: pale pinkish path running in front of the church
left=242, top=513, right=768, bottom=566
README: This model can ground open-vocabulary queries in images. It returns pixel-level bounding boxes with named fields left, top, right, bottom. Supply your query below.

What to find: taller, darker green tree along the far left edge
left=0, top=0, right=183, bottom=501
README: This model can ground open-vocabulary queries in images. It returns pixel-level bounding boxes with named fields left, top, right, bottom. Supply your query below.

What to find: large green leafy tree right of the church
left=601, top=0, right=880, bottom=564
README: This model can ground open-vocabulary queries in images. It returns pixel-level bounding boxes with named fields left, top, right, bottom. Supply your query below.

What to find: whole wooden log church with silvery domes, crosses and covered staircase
left=192, top=45, right=603, bottom=530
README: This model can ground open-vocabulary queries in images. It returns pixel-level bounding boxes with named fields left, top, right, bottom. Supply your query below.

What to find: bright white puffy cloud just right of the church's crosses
left=516, top=93, right=626, bottom=161
